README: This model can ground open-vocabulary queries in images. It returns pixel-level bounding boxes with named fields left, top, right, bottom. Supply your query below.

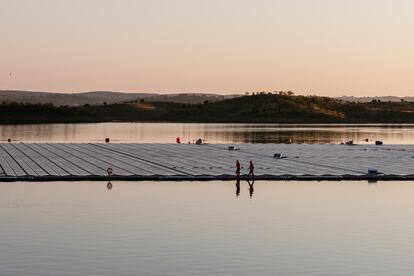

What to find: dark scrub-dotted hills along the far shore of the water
left=0, top=93, right=414, bottom=123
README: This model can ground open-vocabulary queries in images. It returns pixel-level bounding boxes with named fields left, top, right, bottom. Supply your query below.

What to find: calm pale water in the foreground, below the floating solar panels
left=0, top=182, right=414, bottom=276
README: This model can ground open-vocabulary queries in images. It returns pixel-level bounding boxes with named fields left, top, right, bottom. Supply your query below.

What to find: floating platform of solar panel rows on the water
left=0, top=143, right=414, bottom=181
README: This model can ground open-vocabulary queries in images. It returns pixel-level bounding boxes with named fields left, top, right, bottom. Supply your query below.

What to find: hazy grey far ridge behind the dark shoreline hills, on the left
left=0, top=90, right=239, bottom=106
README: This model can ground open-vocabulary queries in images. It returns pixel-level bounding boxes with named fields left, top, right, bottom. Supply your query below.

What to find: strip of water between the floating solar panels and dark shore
left=0, top=123, right=414, bottom=144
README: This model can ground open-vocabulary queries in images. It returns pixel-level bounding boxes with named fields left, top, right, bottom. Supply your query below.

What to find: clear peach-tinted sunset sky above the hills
left=0, top=0, right=414, bottom=96
